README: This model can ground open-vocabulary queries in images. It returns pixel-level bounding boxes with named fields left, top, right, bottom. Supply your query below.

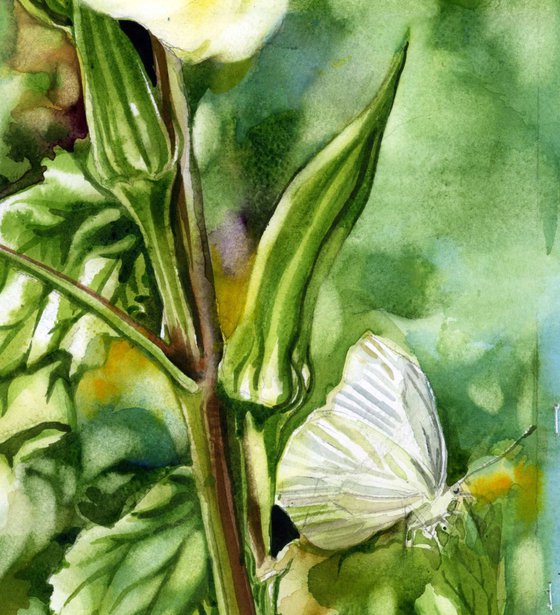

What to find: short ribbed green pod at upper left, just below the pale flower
left=74, top=3, right=174, bottom=186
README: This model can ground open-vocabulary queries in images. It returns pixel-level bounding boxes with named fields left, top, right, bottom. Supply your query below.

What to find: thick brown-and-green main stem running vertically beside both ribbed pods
left=152, top=39, right=256, bottom=615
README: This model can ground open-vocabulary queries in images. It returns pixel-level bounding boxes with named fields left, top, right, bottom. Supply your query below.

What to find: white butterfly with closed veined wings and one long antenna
left=276, top=333, right=534, bottom=550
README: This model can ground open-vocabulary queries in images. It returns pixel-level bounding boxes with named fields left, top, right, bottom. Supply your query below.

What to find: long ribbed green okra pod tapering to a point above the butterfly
left=222, top=41, right=406, bottom=407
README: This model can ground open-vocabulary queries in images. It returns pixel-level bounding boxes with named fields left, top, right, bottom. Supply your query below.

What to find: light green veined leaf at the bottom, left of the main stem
left=51, top=468, right=208, bottom=615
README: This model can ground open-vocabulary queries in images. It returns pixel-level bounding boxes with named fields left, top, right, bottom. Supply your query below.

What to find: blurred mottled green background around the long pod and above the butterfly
left=0, top=0, right=560, bottom=614
